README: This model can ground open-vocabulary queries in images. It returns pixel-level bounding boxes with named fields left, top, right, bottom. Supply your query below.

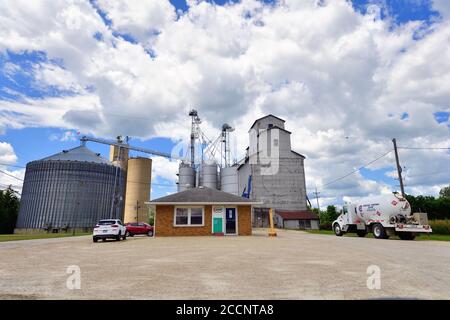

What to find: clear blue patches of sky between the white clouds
left=0, top=0, right=449, bottom=202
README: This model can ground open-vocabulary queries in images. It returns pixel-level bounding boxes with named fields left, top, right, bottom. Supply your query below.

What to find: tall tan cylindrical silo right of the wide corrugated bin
left=123, top=157, right=152, bottom=223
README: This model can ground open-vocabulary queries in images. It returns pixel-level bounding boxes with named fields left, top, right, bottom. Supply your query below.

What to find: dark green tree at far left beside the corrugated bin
left=0, top=187, right=19, bottom=234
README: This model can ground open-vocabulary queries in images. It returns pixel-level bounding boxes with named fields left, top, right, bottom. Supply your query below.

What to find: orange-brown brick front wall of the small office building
left=155, top=205, right=252, bottom=237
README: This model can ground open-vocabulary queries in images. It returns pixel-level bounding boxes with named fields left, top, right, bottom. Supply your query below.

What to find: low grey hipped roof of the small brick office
left=147, top=187, right=262, bottom=205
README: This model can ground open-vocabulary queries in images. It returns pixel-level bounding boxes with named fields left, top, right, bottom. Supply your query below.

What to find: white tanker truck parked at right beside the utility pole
left=332, top=193, right=432, bottom=240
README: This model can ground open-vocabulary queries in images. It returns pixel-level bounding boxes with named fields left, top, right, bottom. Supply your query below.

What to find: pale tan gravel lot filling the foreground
left=0, top=230, right=450, bottom=299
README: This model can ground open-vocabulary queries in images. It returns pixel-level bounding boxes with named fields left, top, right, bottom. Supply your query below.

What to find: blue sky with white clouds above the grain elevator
left=0, top=0, right=450, bottom=205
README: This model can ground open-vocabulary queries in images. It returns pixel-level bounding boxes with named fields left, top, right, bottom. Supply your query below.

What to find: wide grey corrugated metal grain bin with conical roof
left=15, top=146, right=125, bottom=233
